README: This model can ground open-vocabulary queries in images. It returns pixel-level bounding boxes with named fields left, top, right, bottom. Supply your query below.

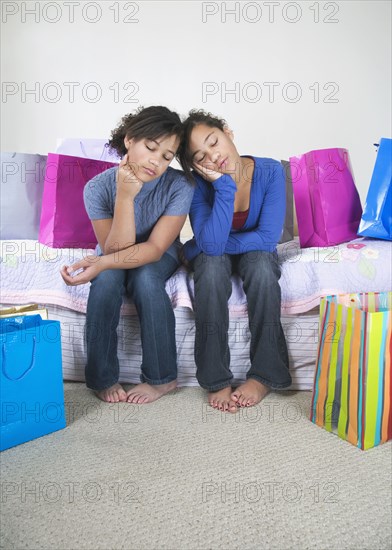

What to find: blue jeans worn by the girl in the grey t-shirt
left=85, top=253, right=178, bottom=390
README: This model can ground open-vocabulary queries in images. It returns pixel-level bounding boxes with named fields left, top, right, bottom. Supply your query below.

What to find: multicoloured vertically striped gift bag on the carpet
left=310, top=292, right=392, bottom=450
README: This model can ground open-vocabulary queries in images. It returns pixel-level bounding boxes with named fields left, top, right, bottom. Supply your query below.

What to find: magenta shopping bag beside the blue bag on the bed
left=290, top=149, right=362, bottom=248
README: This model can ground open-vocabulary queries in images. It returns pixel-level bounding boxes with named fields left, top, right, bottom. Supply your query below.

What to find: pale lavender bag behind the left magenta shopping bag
left=56, top=138, right=121, bottom=163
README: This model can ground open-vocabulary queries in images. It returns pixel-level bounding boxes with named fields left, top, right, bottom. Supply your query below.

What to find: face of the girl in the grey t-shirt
left=124, top=135, right=180, bottom=183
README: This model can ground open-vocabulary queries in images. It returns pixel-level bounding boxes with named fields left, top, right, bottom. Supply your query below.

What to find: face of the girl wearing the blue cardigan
left=189, top=124, right=241, bottom=174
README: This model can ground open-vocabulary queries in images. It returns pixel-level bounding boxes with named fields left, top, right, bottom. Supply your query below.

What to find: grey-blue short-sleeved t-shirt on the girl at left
left=83, top=166, right=194, bottom=259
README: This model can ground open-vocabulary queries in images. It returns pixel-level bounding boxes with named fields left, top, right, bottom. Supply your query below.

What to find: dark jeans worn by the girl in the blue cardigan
left=193, top=251, right=291, bottom=391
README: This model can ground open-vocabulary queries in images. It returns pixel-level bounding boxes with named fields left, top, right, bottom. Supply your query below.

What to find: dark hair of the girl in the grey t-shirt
left=106, top=106, right=183, bottom=157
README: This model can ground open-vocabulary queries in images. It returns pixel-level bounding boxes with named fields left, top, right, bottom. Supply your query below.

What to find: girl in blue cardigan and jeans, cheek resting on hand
left=178, top=110, right=291, bottom=412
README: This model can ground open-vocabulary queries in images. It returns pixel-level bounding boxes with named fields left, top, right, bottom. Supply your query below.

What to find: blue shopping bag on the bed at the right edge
left=358, top=138, right=392, bottom=241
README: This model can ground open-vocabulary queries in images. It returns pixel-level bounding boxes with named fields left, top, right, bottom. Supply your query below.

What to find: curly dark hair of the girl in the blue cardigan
left=176, top=109, right=226, bottom=182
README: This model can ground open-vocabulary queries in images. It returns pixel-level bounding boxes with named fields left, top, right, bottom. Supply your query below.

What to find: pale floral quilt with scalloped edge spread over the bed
left=0, top=238, right=392, bottom=316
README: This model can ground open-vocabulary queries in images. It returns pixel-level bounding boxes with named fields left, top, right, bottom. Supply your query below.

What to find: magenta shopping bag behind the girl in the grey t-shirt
left=38, top=153, right=117, bottom=248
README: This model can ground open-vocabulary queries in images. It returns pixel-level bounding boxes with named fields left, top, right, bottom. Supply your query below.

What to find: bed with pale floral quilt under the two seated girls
left=0, top=238, right=392, bottom=390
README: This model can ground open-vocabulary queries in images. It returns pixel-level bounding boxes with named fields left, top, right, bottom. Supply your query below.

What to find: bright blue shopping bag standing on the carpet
left=0, top=315, right=66, bottom=451
